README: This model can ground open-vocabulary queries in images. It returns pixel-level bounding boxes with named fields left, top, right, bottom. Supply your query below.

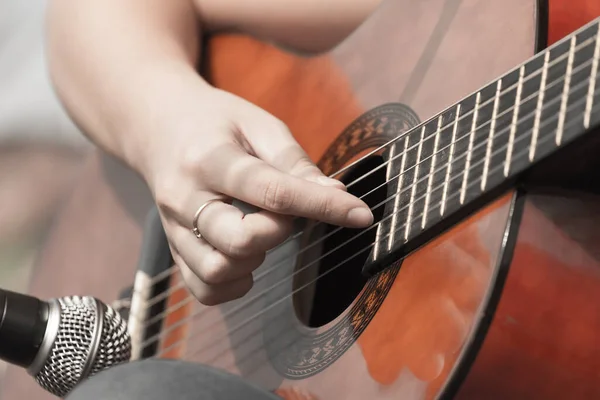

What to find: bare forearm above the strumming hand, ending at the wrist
left=47, top=0, right=200, bottom=170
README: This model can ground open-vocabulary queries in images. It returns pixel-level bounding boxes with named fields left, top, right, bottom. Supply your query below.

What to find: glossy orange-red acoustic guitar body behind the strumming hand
left=2, top=0, right=600, bottom=400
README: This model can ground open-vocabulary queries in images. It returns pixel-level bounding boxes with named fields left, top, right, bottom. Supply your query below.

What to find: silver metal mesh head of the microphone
left=35, top=296, right=131, bottom=397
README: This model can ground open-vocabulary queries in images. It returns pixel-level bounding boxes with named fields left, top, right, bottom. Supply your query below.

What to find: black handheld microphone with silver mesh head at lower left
left=0, top=289, right=131, bottom=397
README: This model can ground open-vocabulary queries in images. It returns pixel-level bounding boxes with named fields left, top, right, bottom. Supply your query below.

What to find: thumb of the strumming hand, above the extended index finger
left=245, top=115, right=346, bottom=191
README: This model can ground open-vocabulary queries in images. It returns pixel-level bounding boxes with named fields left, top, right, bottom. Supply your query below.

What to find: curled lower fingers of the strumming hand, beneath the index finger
left=169, top=197, right=292, bottom=305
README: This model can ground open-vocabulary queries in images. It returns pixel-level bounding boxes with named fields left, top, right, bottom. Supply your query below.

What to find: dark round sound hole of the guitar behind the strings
left=294, top=156, right=387, bottom=328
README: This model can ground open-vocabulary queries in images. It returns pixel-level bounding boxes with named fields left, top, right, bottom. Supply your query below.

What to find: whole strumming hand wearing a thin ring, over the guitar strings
left=143, top=85, right=373, bottom=305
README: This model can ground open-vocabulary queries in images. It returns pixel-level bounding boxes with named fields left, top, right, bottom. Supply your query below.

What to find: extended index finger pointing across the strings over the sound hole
left=200, top=146, right=373, bottom=228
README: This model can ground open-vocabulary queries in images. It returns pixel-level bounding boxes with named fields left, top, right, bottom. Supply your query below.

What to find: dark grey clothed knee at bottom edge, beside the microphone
left=66, top=359, right=281, bottom=400
